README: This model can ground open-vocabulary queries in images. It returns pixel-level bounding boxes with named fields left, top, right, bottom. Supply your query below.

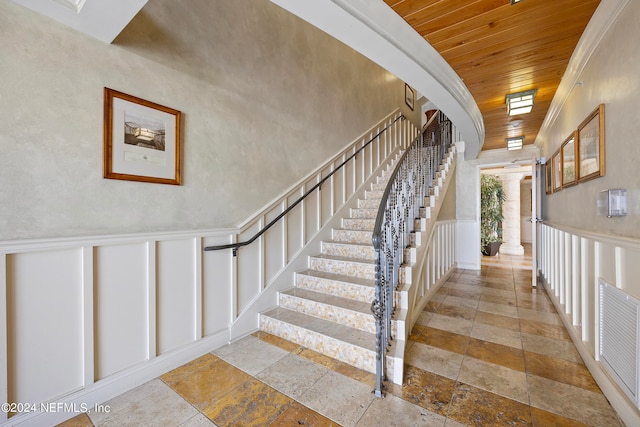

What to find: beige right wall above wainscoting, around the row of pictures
left=542, top=1, right=640, bottom=238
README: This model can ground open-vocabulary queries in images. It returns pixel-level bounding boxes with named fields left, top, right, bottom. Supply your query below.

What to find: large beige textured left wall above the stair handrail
left=0, top=0, right=410, bottom=240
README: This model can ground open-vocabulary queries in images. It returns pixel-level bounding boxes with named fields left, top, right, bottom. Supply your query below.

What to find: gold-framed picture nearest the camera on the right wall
left=577, top=104, right=605, bottom=182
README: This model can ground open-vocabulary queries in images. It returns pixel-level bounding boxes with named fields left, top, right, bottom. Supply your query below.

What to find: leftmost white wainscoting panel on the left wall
left=7, top=249, right=84, bottom=403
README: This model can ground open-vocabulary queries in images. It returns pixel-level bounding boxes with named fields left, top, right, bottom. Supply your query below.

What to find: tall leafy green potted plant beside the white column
left=480, top=174, right=506, bottom=256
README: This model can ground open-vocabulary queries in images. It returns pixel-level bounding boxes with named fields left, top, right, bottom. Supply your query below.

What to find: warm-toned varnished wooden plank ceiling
left=385, top=0, right=600, bottom=150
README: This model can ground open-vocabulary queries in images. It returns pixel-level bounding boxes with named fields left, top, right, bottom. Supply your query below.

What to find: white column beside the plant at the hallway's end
left=499, top=173, right=524, bottom=255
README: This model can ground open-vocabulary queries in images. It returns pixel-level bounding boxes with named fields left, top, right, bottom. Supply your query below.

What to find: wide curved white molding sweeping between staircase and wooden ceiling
left=271, top=0, right=485, bottom=159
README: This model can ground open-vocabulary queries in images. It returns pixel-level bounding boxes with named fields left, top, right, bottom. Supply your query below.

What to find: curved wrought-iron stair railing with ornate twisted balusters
left=371, top=112, right=452, bottom=397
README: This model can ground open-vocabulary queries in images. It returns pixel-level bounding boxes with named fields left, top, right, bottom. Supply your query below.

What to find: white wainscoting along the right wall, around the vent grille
left=538, top=224, right=640, bottom=425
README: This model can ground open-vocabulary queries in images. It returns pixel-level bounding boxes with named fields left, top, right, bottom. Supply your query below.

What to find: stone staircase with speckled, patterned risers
left=260, top=146, right=452, bottom=381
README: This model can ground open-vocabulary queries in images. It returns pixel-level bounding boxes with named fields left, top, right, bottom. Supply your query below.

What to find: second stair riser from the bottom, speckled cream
left=279, top=294, right=376, bottom=334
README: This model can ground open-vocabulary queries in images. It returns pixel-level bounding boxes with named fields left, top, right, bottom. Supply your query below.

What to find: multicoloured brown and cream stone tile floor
left=62, top=246, right=621, bottom=427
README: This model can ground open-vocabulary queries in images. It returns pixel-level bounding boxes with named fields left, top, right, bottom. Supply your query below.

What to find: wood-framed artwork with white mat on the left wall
left=103, top=88, right=181, bottom=185
